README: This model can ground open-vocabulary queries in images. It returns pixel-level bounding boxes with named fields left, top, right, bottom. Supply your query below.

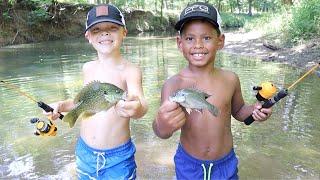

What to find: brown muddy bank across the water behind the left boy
left=0, top=3, right=175, bottom=47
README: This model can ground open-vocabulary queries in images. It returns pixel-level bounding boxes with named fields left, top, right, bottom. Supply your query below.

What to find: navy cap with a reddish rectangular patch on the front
left=85, top=4, right=126, bottom=32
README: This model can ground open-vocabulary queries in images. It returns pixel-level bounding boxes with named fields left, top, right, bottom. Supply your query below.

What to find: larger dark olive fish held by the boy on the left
left=62, top=81, right=126, bottom=127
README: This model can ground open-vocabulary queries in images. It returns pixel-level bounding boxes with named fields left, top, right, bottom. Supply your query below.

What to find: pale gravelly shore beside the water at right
left=223, top=31, right=320, bottom=69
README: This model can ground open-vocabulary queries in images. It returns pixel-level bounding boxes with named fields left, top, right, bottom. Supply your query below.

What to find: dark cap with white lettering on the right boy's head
left=174, top=2, right=221, bottom=31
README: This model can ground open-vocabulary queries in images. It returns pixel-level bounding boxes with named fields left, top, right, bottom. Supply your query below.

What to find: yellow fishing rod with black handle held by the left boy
left=0, top=80, right=64, bottom=119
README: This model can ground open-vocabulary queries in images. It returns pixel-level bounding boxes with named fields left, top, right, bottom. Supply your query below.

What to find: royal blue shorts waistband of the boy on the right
left=177, top=143, right=236, bottom=165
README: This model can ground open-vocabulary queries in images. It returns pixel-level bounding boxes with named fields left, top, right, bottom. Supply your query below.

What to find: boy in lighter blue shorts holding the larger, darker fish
left=48, top=5, right=147, bottom=179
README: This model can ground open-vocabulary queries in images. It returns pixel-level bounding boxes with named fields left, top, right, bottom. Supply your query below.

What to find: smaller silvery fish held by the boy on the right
left=169, top=88, right=219, bottom=117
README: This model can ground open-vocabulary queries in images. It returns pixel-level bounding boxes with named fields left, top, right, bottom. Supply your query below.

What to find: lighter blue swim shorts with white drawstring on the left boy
left=76, top=137, right=137, bottom=180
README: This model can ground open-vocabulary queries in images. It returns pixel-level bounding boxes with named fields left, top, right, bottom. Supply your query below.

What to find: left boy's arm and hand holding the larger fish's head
left=116, top=66, right=148, bottom=119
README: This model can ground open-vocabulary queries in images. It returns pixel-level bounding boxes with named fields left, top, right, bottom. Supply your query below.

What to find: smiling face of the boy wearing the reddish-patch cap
left=85, top=22, right=127, bottom=54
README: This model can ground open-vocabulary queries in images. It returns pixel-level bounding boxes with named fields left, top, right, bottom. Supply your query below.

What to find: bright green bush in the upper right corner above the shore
left=288, top=0, right=320, bottom=42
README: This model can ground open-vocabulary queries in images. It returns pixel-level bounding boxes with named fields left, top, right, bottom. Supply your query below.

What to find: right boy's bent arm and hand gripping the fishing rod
left=231, top=76, right=272, bottom=122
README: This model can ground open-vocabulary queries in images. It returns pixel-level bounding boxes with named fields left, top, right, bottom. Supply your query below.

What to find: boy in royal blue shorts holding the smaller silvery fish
left=153, top=2, right=271, bottom=180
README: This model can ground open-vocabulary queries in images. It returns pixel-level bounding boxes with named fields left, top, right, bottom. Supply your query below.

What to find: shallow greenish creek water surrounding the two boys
left=0, top=36, right=320, bottom=179
